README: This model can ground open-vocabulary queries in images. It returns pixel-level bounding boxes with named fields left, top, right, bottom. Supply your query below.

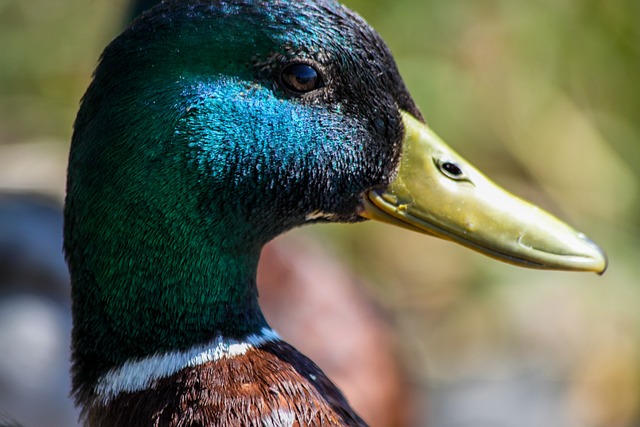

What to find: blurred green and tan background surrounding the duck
left=0, top=0, right=640, bottom=427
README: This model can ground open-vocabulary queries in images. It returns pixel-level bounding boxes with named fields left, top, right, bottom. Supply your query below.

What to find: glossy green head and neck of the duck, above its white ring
left=65, top=0, right=420, bottom=402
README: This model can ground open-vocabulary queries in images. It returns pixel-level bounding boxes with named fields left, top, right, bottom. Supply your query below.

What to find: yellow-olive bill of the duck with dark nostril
left=359, top=112, right=607, bottom=273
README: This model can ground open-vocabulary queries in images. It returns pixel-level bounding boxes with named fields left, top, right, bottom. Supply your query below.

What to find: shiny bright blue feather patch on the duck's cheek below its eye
left=176, top=77, right=362, bottom=202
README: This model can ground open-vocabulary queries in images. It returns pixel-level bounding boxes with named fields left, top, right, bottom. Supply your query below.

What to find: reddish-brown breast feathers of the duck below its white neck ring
left=87, top=342, right=366, bottom=427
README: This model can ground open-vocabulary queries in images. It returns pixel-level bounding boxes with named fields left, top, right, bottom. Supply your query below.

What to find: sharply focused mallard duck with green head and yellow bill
left=64, top=0, right=606, bottom=426
